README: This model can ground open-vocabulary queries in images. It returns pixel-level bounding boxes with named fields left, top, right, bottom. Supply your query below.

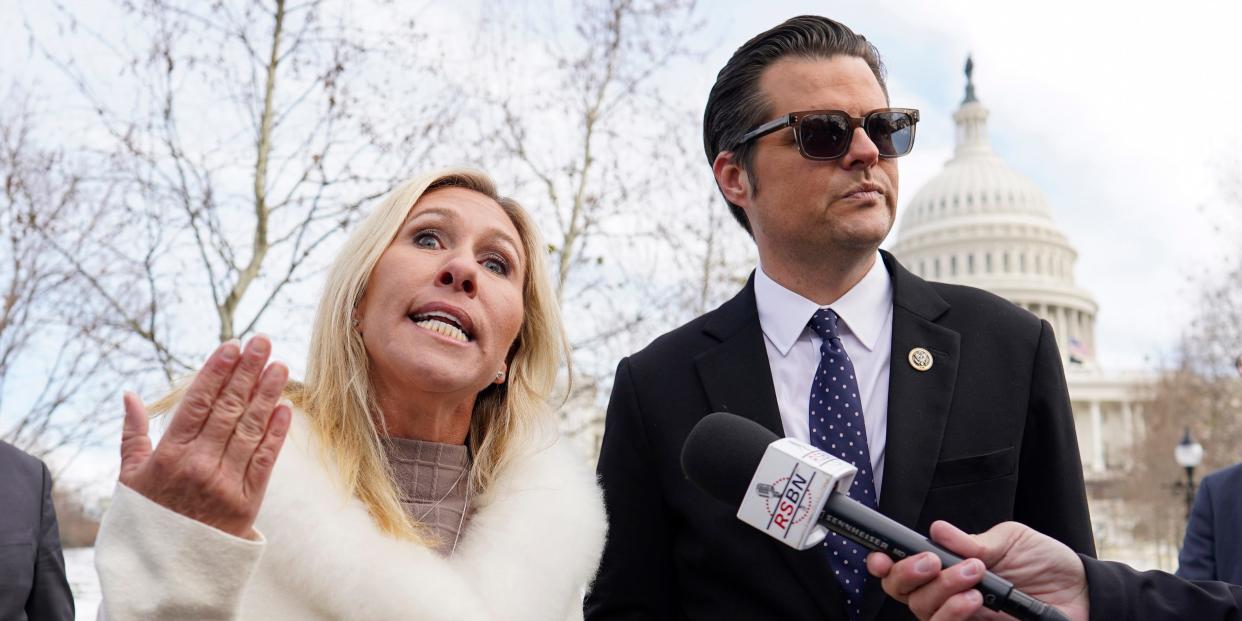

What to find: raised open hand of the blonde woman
left=120, top=335, right=292, bottom=539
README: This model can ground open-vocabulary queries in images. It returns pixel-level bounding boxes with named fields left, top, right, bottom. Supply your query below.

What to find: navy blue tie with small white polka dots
left=810, top=308, right=878, bottom=621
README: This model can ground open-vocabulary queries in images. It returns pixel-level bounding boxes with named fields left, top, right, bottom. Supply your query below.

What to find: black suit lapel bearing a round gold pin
left=864, top=251, right=961, bottom=616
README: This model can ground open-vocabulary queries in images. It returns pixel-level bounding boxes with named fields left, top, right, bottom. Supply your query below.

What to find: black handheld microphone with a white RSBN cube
left=682, top=412, right=1067, bottom=621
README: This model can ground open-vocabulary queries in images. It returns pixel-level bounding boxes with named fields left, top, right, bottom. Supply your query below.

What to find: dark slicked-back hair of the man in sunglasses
left=703, top=15, right=888, bottom=236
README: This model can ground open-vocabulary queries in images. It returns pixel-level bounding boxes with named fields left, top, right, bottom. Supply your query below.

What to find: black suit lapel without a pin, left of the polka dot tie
left=694, top=274, right=845, bottom=619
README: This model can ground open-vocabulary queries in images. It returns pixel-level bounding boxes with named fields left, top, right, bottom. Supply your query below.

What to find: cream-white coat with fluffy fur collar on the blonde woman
left=96, top=414, right=606, bottom=621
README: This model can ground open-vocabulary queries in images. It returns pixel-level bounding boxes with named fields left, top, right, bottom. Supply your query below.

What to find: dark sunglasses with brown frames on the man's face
left=733, top=108, right=919, bottom=160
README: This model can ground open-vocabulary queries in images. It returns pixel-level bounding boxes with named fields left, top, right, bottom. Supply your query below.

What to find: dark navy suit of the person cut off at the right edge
left=1177, top=463, right=1242, bottom=585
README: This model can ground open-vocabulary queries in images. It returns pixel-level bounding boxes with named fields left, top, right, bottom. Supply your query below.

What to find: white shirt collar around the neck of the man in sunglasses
left=755, top=253, right=893, bottom=356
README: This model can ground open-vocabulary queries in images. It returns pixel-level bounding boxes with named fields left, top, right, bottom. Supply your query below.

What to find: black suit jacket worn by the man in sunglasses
left=586, top=253, right=1094, bottom=620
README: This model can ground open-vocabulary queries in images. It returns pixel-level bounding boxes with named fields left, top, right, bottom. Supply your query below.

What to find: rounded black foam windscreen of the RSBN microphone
left=682, top=412, right=779, bottom=507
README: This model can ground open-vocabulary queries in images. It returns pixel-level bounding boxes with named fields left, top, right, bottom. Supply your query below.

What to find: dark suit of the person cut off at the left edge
left=0, top=442, right=73, bottom=620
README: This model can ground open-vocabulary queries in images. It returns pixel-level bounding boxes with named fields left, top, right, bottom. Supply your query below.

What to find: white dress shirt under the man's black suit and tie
left=755, top=253, right=893, bottom=499
